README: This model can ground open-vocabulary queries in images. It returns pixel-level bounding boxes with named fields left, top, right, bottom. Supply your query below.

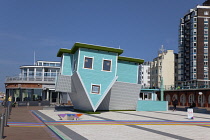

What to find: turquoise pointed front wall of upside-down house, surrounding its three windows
left=78, top=48, right=117, bottom=106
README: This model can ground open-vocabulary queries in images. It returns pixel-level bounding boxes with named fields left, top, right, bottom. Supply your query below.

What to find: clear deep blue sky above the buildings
left=0, top=0, right=205, bottom=91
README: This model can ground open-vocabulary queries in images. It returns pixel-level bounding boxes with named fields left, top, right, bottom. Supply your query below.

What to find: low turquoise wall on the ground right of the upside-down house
left=136, top=100, right=168, bottom=111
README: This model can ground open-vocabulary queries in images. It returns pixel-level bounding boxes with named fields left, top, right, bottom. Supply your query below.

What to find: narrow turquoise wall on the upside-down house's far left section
left=61, top=53, right=72, bottom=75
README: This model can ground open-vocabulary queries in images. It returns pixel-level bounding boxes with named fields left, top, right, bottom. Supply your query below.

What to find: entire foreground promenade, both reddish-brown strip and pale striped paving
left=5, top=107, right=210, bottom=140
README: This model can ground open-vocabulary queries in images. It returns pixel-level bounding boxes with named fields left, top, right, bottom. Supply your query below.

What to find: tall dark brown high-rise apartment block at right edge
left=178, top=0, right=210, bottom=86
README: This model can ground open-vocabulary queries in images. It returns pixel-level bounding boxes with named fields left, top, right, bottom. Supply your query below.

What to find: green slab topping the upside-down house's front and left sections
left=57, top=43, right=123, bottom=57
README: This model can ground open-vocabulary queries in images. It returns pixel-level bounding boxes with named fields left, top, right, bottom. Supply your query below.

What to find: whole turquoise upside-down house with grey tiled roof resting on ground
left=56, top=43, right=144, bottom=111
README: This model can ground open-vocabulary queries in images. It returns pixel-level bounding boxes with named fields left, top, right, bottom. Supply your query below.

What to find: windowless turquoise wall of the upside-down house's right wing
left=117, top=61, right=138, bottom=83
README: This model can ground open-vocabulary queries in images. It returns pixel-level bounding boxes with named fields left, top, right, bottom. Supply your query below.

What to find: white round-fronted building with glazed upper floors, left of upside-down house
left=5, top=61, right=60, bottom=105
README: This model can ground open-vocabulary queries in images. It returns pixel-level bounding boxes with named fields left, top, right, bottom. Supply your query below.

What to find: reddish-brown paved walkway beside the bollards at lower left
left=4, top=107, right=59, bottom=140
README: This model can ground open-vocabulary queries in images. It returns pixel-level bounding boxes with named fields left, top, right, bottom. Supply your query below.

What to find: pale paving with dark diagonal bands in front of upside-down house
left=34, top=107, right=210, bottom=140
